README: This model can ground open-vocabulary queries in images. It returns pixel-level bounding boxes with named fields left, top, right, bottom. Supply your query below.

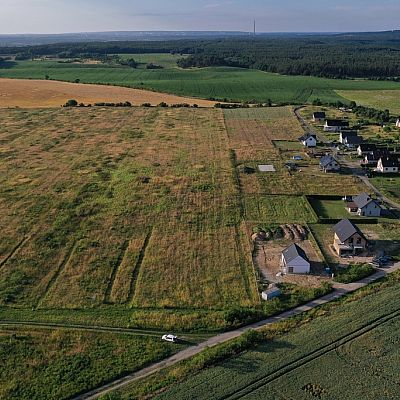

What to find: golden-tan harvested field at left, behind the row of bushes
left=0, top=79, right=215, bottom=108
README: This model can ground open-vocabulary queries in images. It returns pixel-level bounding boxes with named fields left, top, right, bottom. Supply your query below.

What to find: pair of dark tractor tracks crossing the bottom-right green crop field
left=218, top=310, right=400, bottom=400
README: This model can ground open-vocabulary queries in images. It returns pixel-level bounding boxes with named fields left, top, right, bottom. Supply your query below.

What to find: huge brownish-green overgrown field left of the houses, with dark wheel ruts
left=0, top=108, right=259, bottom=318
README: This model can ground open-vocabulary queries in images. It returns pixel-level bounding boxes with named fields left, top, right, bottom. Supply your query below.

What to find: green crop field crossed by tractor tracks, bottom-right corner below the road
left=150, top=284, right=400, bottom=400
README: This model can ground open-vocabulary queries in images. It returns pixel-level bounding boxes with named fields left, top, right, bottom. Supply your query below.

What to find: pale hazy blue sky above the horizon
left=0, top=0, right=400, bottom=34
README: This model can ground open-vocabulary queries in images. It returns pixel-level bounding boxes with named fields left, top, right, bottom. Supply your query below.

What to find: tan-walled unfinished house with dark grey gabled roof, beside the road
left=333, top=219, right=368, bottom=257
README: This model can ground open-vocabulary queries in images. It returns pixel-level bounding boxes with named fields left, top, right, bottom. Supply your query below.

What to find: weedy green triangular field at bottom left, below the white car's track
left=0, top=327, right=184, bottom=400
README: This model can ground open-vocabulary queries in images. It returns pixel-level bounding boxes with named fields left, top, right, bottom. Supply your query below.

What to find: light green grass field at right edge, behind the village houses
left=337, top=90, right=400, bottom=115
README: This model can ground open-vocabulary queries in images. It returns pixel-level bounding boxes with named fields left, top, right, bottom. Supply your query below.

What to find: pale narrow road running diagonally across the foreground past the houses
left=73, top=263, right=400, bottom=400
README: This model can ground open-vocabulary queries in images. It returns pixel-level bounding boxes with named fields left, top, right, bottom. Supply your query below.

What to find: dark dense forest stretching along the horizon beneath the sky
left=0, top=31, right=400, bottom=80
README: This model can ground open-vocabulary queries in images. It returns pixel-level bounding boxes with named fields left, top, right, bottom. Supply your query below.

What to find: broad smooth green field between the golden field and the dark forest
left=0, top=59, right=400, bottom=104
